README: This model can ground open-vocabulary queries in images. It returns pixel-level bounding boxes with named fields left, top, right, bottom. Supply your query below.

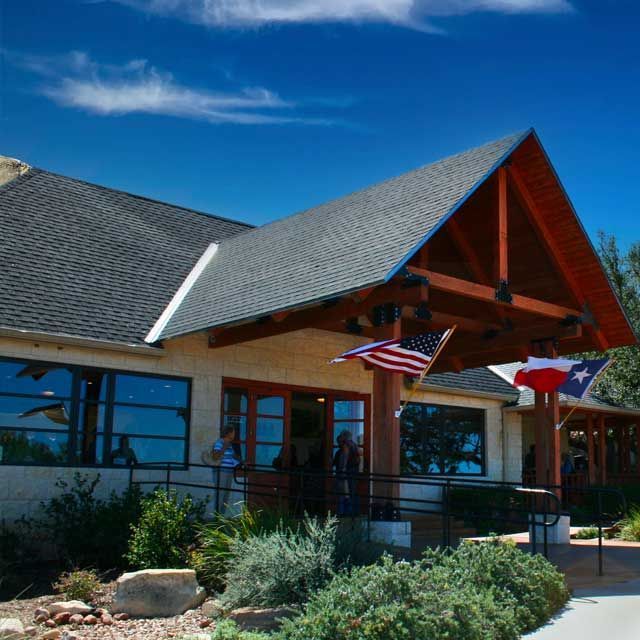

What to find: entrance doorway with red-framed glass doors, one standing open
left=221, top=379, right=371, bottom=514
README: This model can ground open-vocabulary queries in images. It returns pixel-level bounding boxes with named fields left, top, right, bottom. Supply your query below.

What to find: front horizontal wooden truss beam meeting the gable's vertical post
left=407, top=267, right=582, bottom=320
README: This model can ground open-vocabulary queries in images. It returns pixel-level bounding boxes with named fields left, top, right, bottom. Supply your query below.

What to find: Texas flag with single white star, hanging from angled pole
left=513, top=357, right=609, bottom=398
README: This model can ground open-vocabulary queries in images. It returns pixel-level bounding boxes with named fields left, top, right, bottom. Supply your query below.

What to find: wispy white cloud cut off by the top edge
left=116, top=0, right=573, bottom=30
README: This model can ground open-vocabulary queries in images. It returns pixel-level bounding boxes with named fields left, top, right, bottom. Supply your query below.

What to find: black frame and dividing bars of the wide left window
left=0, top=356, right=193, bottom=471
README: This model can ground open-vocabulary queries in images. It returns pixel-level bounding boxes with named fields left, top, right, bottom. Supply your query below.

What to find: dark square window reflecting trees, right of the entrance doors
left=400, top=403, right=485, bottom=475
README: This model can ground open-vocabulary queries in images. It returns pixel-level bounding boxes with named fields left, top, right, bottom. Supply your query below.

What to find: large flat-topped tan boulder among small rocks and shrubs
left=111, top=569, right=206, bottom=618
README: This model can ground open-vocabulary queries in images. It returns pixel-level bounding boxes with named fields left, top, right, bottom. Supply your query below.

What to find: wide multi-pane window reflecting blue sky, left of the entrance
left=0, top=359, right=190, bottom=466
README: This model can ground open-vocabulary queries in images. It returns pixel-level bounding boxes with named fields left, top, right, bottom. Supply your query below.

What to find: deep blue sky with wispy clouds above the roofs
left=0, top=0, right=640, bottom=244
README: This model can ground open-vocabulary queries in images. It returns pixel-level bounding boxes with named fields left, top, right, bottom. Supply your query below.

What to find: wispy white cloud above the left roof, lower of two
left=10, top=51, right=331, bottom=124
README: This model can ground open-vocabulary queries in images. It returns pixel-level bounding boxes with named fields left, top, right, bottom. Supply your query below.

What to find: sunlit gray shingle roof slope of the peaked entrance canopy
left=160, top=132, right=529, bottom=339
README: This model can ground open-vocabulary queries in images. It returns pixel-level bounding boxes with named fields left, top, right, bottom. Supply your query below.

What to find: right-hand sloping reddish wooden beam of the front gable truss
left=509, top=164, right=609, bottom=351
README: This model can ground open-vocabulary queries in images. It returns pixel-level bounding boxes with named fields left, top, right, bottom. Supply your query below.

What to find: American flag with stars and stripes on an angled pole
left=331, top=329, right=451, bottom=376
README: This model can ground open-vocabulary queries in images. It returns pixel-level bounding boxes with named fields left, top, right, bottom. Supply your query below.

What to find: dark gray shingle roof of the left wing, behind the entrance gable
left=0, top=169, right=250, bottom=344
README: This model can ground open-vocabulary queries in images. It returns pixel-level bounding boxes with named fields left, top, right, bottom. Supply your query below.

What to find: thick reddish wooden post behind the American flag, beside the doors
left=371, top=319, right=402, bottom=499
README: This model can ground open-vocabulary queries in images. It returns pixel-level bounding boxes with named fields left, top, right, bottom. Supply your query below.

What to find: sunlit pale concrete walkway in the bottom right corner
left=525, top=580, right=640, bottom=640
